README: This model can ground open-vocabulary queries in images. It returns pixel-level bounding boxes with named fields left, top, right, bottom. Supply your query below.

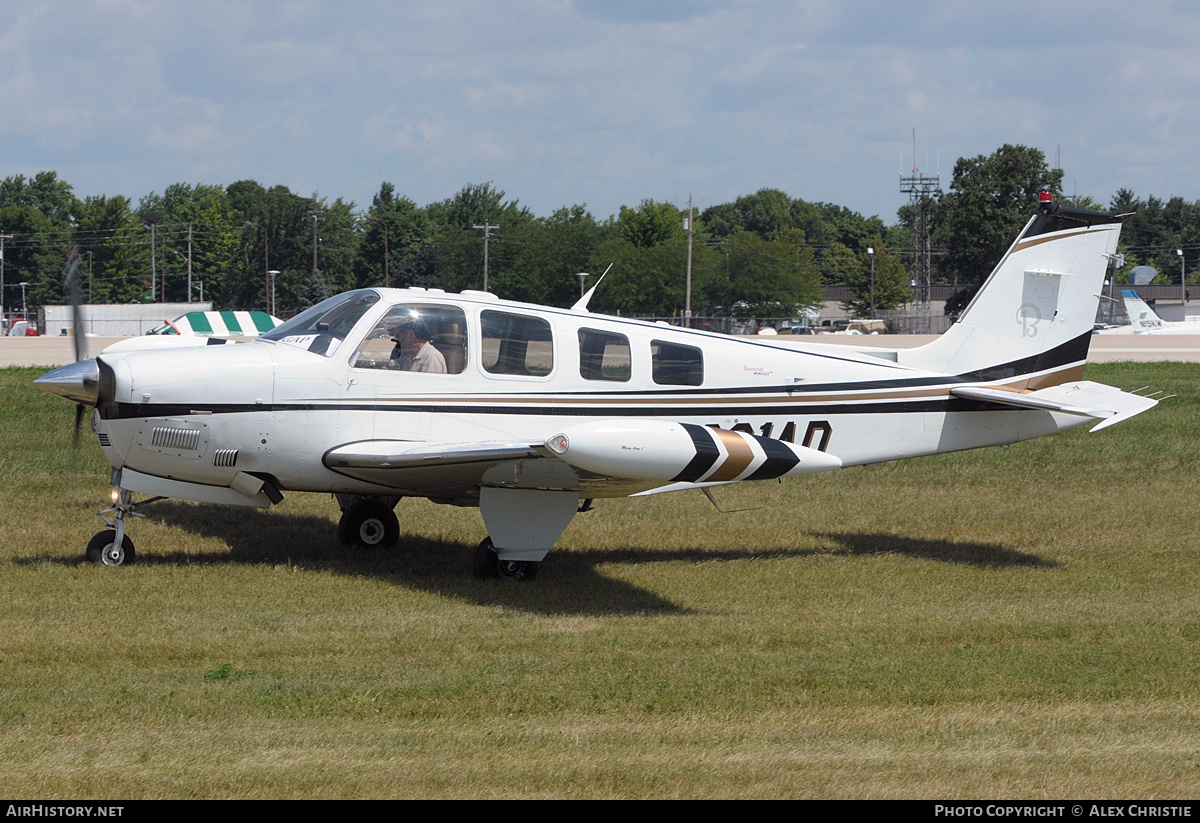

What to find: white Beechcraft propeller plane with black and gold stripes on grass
left=37, top=196, right=1157, bottom=578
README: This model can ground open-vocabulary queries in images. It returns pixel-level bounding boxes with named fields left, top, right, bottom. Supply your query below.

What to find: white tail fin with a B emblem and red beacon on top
left=902, top=199, right=1121, bottom=389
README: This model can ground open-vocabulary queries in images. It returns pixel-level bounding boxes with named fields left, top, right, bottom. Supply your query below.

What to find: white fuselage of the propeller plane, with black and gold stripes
left=92, top=289, right=1085, bottom=505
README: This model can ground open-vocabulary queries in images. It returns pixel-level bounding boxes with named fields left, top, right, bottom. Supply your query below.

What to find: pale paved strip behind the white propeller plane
left=0, top=335, right=1200, bottom=367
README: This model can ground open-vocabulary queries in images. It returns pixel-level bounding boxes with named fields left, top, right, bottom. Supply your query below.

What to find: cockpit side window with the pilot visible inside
left=350, top=304, right=467, bottom=374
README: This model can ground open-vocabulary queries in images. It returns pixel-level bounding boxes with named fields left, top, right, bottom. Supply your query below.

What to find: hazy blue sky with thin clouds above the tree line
left=0, top=0, right=1200, bottom=223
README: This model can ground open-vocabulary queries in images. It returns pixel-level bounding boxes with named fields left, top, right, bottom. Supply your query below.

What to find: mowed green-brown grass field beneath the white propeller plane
left=0, top=364, right=1200, bottom=798
